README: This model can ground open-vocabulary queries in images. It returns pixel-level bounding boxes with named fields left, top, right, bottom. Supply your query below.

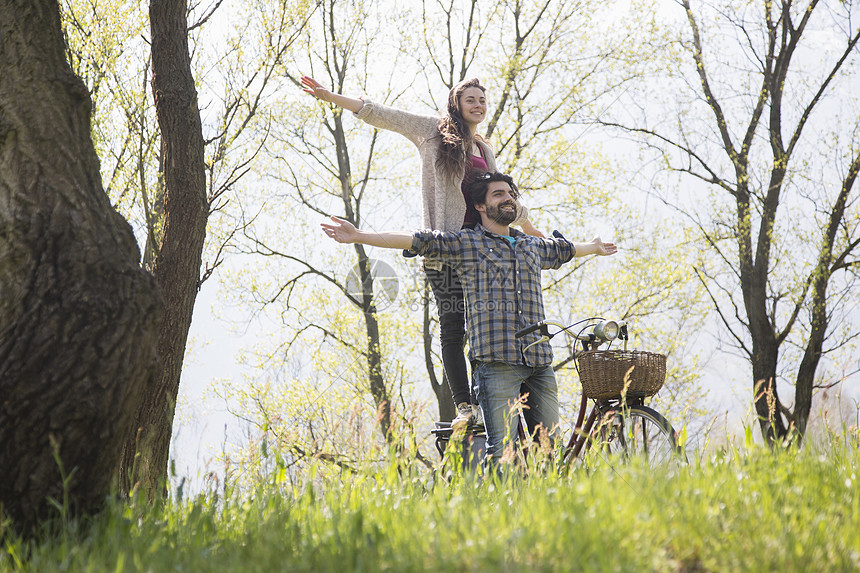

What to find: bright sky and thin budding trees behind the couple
left=0, top=0, right=860, bottom=528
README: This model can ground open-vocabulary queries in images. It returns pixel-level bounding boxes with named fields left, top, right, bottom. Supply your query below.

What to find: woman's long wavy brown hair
left=436, top=78, right=487, bottom=187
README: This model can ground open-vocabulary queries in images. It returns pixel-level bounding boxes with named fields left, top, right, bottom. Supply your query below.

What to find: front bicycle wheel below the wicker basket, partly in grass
left=592, top=406, right=687, bottom=467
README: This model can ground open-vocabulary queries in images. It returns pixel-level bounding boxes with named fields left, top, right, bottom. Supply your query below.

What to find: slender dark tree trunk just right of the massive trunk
left=119, top=0, right=209, bottom=499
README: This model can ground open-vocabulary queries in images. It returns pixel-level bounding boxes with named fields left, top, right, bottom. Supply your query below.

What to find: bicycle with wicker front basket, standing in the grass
left=431, top=317, right=687, bottom=469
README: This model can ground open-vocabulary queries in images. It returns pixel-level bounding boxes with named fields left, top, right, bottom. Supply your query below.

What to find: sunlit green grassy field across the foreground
left=0, top=436, right=860, bottom=573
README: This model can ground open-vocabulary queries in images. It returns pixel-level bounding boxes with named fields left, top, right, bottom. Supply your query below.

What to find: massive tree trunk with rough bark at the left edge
left=0, top=0, right=160, bottom=531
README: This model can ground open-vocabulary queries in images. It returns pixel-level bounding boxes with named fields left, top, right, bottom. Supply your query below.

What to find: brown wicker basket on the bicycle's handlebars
left=579, top=350, right=666, bottom=399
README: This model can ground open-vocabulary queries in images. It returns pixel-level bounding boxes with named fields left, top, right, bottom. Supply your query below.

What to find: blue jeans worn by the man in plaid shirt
left=474, top=362, right=558, bottom=462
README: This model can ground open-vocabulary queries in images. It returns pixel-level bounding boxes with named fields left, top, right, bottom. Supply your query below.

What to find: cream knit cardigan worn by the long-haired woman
left=356, top=97, right=528, bottom=233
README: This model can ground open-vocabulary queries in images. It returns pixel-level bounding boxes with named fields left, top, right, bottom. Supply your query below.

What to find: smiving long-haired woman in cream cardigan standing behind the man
left=302, top=76, right=543, bottom=427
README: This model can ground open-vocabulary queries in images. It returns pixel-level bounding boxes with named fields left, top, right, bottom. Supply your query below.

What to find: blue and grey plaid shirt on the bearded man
left=412, top=225, right=576, bottom=366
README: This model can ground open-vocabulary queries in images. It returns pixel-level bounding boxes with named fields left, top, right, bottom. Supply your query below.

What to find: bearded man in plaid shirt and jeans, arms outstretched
left=322, top=172, right=617, bottom=462
